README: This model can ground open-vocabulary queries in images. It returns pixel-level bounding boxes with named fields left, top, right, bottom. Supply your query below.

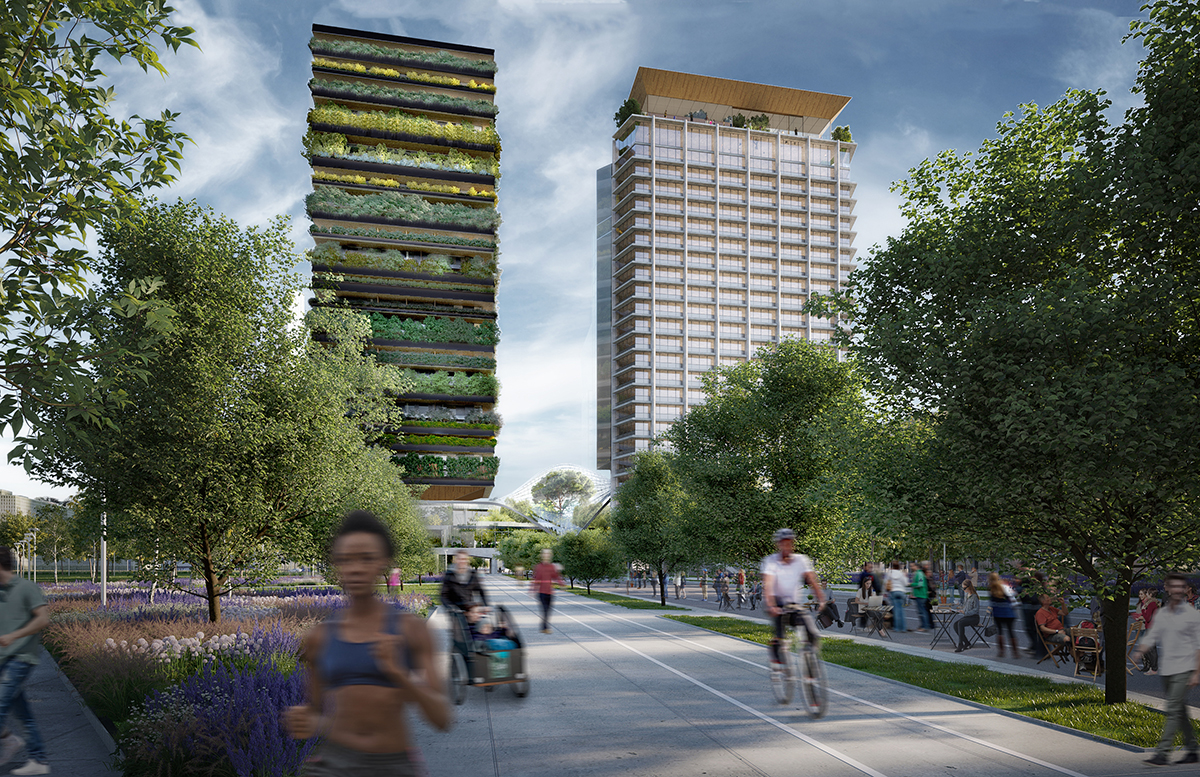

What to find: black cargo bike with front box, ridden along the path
left=445, top=606, right=529, bottom=704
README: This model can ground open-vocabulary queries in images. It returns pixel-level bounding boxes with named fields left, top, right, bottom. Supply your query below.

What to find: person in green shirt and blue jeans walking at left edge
left=0, top=548, right=50, bottom=775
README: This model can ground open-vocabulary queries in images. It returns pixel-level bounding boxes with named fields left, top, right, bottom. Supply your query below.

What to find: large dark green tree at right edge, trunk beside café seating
left=820, top=2, right=1200, bottom=703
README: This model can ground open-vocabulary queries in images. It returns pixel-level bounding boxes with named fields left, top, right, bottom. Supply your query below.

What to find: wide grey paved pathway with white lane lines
left=416, top=576, right=1194, bottom=777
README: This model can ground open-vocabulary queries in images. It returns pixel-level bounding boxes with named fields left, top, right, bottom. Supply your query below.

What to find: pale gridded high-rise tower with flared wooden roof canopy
left=596, top=67, right=856, bottom=481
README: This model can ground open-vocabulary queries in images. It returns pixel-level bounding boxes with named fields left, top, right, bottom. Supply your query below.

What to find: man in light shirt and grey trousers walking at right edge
left=1132, top=572, right=1200, bottom=766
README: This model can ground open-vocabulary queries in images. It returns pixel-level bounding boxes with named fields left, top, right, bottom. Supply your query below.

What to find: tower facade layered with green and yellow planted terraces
left=305, top=25, right=500, bottom=500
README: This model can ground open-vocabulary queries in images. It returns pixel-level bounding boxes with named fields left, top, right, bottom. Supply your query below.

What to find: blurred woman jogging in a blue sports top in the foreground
left=284, top=510, right=450, bottom=777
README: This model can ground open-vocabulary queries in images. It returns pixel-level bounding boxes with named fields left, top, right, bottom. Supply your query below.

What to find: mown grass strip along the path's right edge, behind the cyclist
left=665, top=615, right=1200, bottom=747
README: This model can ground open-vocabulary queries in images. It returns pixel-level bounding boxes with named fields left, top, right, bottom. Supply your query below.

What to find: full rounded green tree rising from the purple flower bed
left=38, top=203, right=417, bottom=621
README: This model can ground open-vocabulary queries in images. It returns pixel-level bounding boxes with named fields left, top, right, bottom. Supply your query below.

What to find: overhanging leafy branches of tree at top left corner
left=0, top=0, right=196, bottom=448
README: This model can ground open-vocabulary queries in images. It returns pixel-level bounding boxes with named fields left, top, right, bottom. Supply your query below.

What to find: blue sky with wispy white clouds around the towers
left=0, top=0, right=1156, bottom=498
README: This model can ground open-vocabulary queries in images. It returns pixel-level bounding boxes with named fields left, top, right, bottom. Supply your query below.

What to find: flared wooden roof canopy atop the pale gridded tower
left=629, top=67, right=850, bottom=135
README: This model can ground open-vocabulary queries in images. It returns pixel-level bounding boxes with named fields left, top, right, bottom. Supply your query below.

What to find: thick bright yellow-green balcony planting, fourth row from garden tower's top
left=308, top=103, right=500, bottom=151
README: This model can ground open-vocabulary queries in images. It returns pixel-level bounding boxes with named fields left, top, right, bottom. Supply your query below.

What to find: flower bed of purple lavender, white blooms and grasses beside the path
left=43, top=580, right=430, bottom=777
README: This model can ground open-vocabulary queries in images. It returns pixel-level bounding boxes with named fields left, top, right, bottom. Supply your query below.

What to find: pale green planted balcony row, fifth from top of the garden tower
left=304, top=131, right=500, bottom=183
